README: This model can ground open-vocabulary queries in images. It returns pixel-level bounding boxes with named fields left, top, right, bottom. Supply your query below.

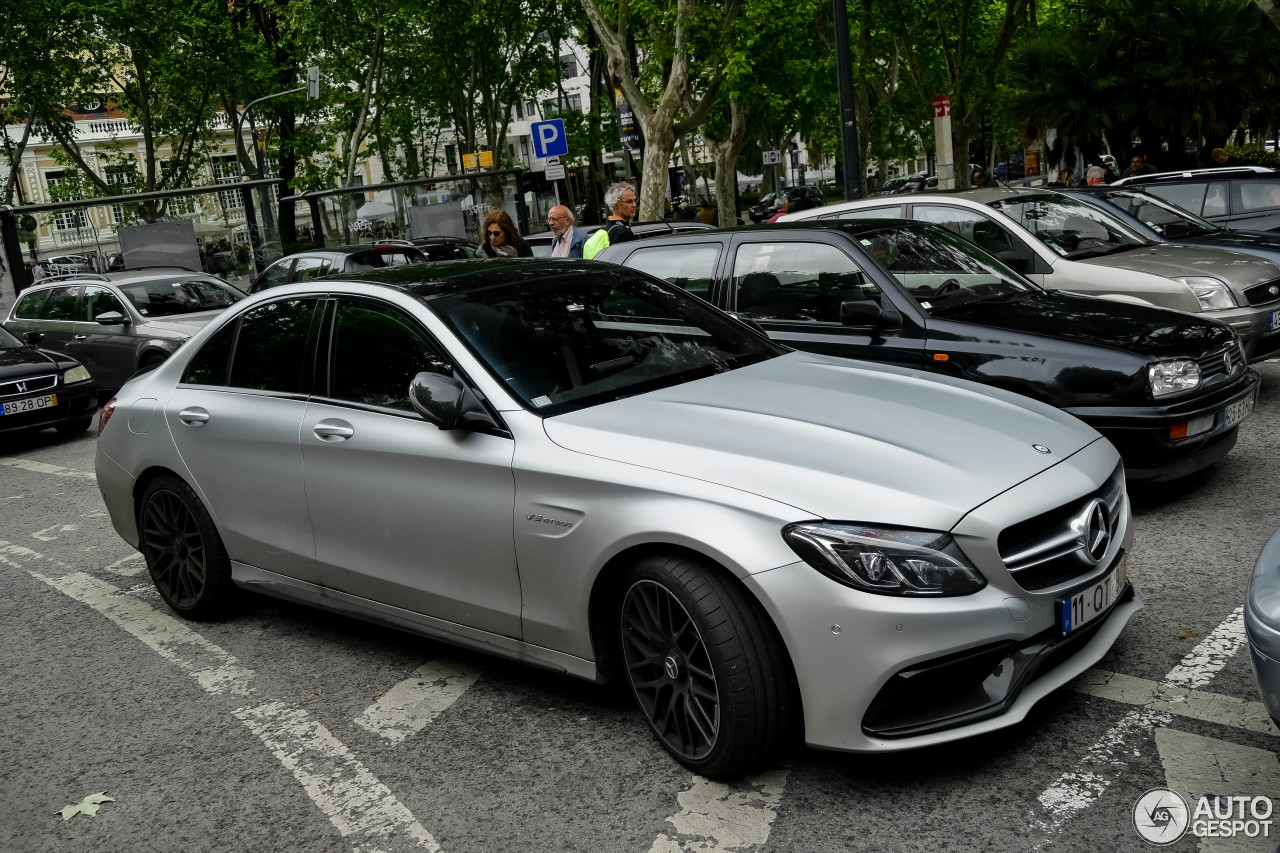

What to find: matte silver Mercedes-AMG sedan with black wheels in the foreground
left=96, top=260, right=1140, bottom=775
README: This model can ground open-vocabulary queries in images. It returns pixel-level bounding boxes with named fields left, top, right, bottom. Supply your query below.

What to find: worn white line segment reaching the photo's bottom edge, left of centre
left=234, top=702, right=440, bottom=853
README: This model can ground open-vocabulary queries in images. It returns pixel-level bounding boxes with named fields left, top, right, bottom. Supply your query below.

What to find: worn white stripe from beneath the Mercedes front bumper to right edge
left=1070, top=670, right=1280, bottom=735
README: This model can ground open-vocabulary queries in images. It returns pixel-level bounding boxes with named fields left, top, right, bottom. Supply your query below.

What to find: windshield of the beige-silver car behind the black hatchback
left=991, top=196, right=1147, bottom=260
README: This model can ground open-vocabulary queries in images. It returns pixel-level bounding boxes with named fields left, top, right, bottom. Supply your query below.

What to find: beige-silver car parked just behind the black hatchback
left=786, top=187, right=1280, bottom=357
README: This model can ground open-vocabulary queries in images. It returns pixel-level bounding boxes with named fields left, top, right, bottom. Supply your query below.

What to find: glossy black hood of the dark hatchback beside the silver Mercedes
left=936, top=292, right=1234, bottom=360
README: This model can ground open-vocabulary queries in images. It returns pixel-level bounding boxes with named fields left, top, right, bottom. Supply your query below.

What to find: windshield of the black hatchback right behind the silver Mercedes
left=858, top=223, right=1039, bottom=314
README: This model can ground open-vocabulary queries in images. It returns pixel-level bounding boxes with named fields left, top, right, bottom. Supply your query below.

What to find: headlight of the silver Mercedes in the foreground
left=782, top=523, right=987, bottom=596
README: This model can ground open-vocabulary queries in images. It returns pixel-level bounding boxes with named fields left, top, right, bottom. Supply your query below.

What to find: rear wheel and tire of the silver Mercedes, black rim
left=138, top=474, right=238, bottom=621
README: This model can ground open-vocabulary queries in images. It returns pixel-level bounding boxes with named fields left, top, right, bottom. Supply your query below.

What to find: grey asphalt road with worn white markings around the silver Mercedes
left=0, top=362, right=1280, bottom=853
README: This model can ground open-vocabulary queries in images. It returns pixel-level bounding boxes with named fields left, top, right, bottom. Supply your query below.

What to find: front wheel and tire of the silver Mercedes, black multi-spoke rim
left=618, top=556, right=796, bottom=776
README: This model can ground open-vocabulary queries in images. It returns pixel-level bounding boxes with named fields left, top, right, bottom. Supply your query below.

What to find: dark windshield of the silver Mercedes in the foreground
left=428, top=270, right=785, bottom=416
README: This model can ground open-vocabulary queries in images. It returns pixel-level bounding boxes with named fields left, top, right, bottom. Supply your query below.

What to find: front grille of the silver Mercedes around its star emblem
left=997, top=462, right=1124, bottom=592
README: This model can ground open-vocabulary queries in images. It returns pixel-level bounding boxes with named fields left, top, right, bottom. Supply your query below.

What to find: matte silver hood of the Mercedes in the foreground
left=544, top=352, right=1100, bottom=530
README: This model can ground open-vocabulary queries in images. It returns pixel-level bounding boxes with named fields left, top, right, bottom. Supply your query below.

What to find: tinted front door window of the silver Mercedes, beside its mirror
left=328, top=300, right=453, bottom=411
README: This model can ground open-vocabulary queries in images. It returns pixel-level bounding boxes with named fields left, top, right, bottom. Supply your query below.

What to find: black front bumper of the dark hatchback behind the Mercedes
left=1066, top=370, right=1261, bottom=483
